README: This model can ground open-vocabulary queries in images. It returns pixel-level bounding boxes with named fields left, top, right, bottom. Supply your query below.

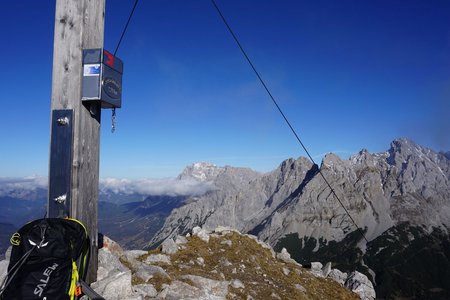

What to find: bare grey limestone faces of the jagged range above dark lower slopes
left=152, top=139, right=450, bottom=248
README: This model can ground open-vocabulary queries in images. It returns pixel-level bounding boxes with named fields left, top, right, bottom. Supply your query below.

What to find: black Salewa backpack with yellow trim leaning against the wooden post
left=0, top=218, right=103, bottom=300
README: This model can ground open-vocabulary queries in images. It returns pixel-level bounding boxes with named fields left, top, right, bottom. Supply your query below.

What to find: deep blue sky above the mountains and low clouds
left=0, top=0, right=450, bottom=178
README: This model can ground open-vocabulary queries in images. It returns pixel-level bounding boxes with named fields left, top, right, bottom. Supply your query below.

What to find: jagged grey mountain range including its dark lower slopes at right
left=148, top=139, right=450, bottom=299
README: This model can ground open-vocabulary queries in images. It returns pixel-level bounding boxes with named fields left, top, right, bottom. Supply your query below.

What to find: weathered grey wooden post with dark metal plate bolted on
left=47, top=0, right=105, bottom=283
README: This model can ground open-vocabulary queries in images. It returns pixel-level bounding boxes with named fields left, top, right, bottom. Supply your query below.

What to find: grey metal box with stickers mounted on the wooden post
left=81, top=48, right=123, bottom=108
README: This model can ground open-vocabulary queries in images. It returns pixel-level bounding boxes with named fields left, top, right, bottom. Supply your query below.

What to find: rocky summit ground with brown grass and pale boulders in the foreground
left=91, top=227, right=375, bottom=300
